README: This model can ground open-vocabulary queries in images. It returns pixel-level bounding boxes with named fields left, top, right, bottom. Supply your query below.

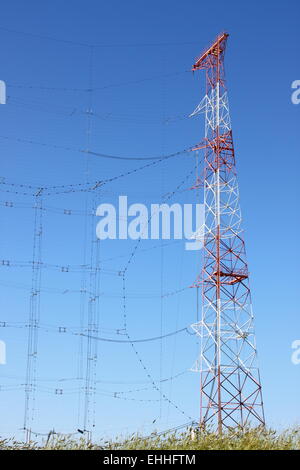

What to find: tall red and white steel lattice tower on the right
left=192, top=33, right=265, bottom=433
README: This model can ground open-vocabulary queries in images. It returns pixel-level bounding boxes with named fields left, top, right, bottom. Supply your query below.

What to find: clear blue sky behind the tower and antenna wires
left=0, top=0, right=300, bottom=437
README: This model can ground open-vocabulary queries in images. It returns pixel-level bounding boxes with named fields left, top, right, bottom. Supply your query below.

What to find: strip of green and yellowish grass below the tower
left=0, top=428, right=300, bottom=450
